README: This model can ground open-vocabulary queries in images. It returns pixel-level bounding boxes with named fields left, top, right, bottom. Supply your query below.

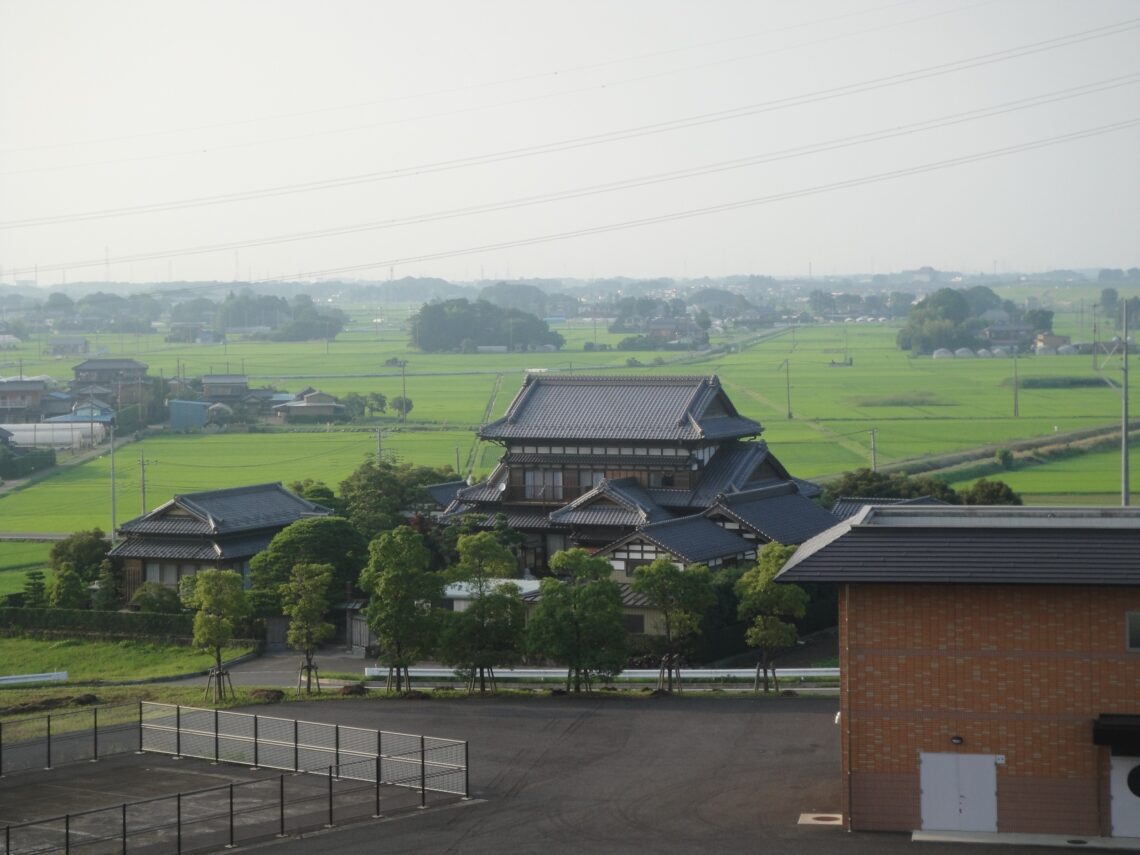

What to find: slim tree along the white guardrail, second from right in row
left=633, top=557, right=716, bottom=692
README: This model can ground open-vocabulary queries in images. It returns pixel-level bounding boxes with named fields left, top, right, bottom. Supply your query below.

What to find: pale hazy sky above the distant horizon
left=0, top=0, right=1140, bottom=286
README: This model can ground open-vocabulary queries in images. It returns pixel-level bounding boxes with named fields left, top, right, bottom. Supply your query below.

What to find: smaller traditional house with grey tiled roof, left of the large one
left=108, top=483, right=332, bottom=597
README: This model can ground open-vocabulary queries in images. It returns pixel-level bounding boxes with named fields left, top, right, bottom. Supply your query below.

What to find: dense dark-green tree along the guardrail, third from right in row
left=527, top=549, right=626, bottom=692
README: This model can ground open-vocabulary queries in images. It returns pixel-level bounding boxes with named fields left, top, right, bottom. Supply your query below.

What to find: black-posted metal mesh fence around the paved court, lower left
left=0, top=701, right=470, bottom=855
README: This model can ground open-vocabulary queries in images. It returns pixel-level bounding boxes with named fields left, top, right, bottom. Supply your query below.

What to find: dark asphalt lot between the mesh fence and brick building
left=0, top=694, right=1062, bottom=855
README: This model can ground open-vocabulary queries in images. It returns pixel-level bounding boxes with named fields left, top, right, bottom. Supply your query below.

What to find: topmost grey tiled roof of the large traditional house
left=479, top=374, right=762, bottom=441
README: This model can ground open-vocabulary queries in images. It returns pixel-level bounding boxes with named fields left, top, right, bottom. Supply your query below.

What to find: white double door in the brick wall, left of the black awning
left=919, top=751, right=998, bottom=831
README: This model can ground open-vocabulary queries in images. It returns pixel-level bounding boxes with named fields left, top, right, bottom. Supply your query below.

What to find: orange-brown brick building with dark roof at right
left=779, top=506, right=1140, bottom=838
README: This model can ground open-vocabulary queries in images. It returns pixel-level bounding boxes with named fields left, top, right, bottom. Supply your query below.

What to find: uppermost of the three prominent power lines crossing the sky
left=0, top=18, right=1140, bottom=229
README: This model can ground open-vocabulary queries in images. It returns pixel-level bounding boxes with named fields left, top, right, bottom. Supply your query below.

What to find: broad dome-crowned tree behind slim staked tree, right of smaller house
left=250, top=516, right=368, bottom=617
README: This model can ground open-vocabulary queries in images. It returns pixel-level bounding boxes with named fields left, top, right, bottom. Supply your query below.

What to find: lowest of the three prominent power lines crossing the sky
left=254, top=117, right=1140, bottom=283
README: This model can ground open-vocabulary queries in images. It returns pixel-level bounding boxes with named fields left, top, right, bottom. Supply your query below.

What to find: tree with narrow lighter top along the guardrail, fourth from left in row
left=442, top=531, right=526, bottom=692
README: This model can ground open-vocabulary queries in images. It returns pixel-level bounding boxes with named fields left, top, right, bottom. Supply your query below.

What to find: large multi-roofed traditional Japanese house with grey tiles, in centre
left=433, top=373, right=836, bottom=576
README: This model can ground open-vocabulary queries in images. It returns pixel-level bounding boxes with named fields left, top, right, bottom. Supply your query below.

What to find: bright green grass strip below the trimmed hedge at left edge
left=0, top=637, right=251, bottom=683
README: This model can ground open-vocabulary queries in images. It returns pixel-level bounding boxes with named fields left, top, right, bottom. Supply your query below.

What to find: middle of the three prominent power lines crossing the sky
left=13, top=73, right=1140, bottom=275
